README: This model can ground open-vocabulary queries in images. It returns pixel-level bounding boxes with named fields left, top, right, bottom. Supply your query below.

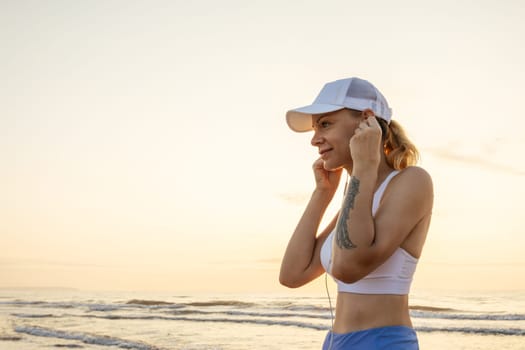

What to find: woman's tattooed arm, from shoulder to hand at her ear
left=331, top=118, right=433, bottom=283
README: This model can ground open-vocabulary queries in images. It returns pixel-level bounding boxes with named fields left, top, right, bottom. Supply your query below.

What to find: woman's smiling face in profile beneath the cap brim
left=311, top=109, right=364, bottom=170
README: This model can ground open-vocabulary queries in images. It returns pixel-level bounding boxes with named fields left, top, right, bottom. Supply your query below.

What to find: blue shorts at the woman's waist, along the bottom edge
left=323, top=326, right=419, bottom=350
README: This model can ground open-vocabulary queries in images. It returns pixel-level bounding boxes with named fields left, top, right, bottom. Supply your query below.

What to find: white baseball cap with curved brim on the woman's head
left=286, top=77, right=392, bottom=132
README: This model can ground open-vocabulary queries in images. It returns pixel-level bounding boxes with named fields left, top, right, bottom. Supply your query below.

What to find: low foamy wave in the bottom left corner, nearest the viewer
left=15, top=326, right=161, bottom=350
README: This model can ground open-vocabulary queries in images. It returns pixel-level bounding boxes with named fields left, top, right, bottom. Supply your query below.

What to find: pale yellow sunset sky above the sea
left=0, top=0, right=525, bottom=293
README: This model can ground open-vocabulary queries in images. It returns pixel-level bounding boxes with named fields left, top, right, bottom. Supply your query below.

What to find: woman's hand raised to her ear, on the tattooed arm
left=349, top=116, right=381, bottom=170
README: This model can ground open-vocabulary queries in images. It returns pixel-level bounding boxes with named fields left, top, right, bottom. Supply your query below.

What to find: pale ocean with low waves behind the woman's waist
left=0, top=289, right=525, bottom=350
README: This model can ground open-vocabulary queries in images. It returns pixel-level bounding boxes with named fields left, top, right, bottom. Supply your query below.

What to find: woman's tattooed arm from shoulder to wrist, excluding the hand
left=332, top=167, right=433, bottom=283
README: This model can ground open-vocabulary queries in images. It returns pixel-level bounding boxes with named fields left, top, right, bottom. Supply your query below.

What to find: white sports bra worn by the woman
left=321, top=170, right=418, bottom=295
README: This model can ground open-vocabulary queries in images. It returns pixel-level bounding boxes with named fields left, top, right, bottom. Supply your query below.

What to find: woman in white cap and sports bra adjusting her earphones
left=279, top=78, right=433, bottom=350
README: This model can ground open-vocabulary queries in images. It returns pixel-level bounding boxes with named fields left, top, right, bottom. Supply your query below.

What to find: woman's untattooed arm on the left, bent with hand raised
left=279, top=159, right=341, bottom=288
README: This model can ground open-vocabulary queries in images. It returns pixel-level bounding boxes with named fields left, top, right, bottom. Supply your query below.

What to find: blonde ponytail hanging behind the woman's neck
left=377, top=118, right=419, bottom=170
